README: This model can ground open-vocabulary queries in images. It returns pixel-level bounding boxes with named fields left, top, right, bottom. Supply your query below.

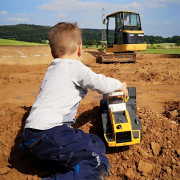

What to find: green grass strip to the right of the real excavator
left=138, top=48, right=180, bottom=54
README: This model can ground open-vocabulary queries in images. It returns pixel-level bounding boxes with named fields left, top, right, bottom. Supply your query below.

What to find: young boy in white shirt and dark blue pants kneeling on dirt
left=22, top=22, right=128, bottom=180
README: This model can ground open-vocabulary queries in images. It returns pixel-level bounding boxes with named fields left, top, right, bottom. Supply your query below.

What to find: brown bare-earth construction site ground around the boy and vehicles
left=0, top=46, right=180, bottom=180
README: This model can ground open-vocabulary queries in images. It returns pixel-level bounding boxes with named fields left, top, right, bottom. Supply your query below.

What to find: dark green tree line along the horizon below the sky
left=0, top=24, right=180, bottom=45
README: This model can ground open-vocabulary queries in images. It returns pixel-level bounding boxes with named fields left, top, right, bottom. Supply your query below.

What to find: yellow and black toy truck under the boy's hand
left=100, top=87, right=142, bottom=147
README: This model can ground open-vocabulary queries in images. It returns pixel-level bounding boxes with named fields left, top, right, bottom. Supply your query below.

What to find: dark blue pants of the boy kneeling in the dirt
left=23, top=125, right=110, bottom=180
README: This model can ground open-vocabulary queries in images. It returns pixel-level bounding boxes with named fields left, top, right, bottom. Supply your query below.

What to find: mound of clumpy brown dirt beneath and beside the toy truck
left=77, top=103, right=180, bottom=180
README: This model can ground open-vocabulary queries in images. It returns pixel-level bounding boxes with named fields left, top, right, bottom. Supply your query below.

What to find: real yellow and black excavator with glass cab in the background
left=102, top=11, right=147, bottom=63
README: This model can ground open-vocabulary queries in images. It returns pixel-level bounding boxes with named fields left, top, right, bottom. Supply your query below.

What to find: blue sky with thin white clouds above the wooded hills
left=0, top=0, right=180, bottom=37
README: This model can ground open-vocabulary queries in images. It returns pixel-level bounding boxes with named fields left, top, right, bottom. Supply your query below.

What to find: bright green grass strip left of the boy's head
left=0, top=39, right=47, bottom=46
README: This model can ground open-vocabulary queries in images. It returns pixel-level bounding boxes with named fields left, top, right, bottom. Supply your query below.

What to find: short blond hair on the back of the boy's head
left=48, top=22, right=82, bottom=58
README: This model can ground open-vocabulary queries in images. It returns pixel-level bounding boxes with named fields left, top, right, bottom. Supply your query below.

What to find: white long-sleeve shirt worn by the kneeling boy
left=25, top=58, right=122, bottom=130
